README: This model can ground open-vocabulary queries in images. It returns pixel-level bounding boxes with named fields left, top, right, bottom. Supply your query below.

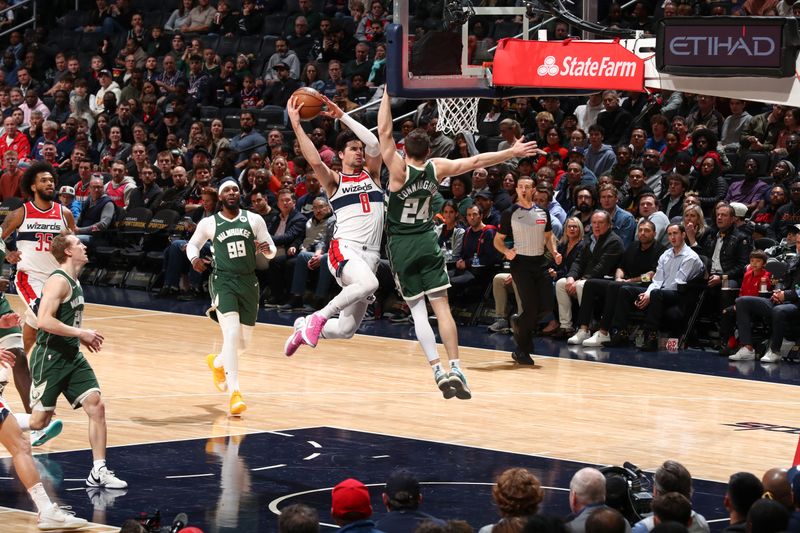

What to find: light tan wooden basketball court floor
left=0, top=296, right=800, bottom=531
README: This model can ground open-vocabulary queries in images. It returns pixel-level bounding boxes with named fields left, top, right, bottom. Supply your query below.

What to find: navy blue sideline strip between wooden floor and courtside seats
left=79, top=286, right=800, bottom=385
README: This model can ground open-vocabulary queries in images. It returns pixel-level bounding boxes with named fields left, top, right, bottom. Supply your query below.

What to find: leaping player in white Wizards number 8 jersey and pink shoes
left=284, top=97, right=384, bottom=355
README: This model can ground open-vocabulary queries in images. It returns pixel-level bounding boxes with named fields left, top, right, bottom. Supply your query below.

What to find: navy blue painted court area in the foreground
left=0, top=422, right=727, bottom=533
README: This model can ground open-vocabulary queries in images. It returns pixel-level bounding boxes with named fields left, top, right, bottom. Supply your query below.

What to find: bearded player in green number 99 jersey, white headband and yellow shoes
left=186, top=180, right=276, bottom=416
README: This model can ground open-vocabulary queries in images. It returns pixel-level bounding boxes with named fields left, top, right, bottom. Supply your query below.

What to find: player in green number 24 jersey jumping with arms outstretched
left=378, top=91, right=537, bottom=400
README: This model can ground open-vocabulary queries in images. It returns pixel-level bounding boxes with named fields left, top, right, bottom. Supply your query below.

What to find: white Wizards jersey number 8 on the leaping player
left=330, top=170, right=384, bottom=250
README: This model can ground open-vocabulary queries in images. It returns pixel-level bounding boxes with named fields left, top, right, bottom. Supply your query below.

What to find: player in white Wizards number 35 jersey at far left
left=0, top=161, right=75, bottom=446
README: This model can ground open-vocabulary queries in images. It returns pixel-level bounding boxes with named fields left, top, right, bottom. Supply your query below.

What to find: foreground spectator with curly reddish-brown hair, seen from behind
left=479, top=468, right=548, bottom=533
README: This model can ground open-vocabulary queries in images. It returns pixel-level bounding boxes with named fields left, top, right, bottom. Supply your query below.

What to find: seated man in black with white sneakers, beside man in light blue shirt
left=567, top=220, right=664, bottom=346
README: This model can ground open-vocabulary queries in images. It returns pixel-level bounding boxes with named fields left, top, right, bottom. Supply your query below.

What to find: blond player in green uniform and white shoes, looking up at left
left=30, top=233, right=128, bottom=489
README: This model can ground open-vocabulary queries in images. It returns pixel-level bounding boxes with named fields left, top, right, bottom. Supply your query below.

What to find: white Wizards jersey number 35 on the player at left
left=17, top=202, right=67, bottom=277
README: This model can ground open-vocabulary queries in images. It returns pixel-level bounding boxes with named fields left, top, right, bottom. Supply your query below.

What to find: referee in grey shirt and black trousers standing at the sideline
left=494, top=176, right=561, bottom=365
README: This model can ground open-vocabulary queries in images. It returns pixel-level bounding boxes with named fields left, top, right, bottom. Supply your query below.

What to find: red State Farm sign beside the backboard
left=492, top=39, right=644, bottom=91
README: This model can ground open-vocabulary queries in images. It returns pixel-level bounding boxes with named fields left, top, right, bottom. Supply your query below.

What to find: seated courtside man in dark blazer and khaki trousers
left=552, top=211, right=632, bottom=339
